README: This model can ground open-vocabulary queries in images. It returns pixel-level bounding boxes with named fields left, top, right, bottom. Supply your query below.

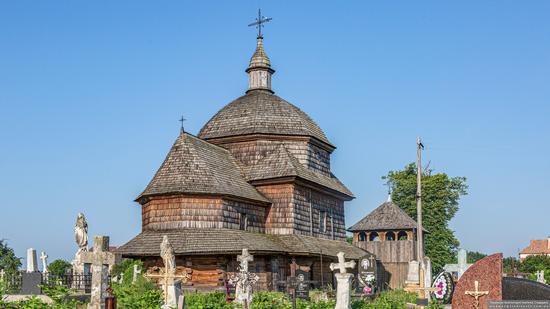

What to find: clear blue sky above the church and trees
left=0, top=0, right=550, bottom=260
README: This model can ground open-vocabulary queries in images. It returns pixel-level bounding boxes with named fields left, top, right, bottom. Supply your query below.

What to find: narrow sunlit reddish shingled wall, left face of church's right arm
left=256, top=184, right=294, bottom=235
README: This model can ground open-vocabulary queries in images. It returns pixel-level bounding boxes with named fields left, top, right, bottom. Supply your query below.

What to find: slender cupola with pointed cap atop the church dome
left=246, top=35, right=275, bottom=93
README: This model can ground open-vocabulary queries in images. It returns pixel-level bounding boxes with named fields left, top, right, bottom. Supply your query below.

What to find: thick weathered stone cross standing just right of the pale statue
left=80, top=236, right=115, bottom=309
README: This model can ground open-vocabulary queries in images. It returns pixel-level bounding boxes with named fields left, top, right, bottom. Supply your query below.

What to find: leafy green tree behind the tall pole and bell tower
left=382, top=163, right=468, bottom=273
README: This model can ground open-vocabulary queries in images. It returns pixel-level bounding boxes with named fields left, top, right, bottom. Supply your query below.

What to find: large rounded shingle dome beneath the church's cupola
left=199, top=90, right=333, bottom=147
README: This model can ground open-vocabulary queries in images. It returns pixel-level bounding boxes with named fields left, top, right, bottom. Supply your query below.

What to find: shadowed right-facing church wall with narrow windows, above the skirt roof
left=294, top=185, right=346, bottom=240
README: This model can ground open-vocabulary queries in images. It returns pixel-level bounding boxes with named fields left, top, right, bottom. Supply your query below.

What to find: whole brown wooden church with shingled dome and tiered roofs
left=117, top=31, right=367, bottom=290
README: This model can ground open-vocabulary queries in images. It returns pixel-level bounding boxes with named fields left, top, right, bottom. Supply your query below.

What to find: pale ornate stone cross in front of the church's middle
left=229, top=249, right=260, bottom=309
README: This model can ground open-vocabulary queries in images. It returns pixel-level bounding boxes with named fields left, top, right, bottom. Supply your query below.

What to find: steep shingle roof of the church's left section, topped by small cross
left=137, top=132, right=270, bottom=203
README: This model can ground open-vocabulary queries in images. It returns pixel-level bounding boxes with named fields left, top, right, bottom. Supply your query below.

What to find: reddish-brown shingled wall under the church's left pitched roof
left=141, top=195, right=267, bottom=232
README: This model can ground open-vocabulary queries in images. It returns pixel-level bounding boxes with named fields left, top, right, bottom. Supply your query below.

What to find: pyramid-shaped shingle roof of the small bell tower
left=348, top=200, right=417, bottom=232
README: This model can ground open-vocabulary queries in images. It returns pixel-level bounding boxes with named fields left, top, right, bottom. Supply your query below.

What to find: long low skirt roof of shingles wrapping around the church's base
left=117, top=228, right=366, bottom=259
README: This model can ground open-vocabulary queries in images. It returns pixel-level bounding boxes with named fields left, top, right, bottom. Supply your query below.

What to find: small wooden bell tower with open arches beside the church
left=348, top=196, right=424, bottom=288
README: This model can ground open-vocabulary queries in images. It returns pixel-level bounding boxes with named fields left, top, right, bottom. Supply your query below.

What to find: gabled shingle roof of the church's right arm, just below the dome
left=242, top=143, right=354, bottom=199
